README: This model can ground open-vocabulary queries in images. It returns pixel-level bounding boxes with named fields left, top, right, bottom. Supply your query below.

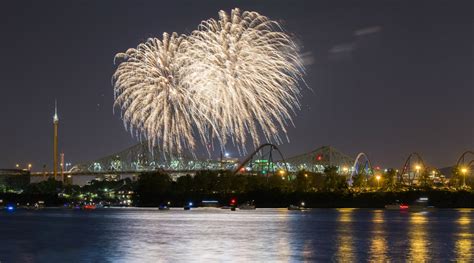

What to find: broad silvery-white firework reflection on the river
left=103, top=209, right=291, bottom=262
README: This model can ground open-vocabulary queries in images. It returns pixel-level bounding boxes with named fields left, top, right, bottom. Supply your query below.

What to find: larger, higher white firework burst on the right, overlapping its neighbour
left=176, top=8, right=303, bottom=154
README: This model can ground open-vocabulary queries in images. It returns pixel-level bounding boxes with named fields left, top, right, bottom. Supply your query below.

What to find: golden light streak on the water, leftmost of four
left=335, top=208, right=357, bottom=262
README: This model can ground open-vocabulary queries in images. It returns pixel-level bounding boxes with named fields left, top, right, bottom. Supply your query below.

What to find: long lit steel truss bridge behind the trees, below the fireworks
left=68, top=143, right=354, bottom=177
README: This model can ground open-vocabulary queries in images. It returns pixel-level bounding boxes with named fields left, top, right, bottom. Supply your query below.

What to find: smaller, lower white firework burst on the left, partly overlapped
left=113, top=33, right=206, bottom=155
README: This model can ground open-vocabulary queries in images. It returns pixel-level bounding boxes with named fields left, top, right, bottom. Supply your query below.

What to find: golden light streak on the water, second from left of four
left=369, top=210, right=388, bottom=262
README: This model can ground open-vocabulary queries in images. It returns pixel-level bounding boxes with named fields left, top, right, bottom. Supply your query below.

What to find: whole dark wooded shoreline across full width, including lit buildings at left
left=0, top=167, right=474, bottom=207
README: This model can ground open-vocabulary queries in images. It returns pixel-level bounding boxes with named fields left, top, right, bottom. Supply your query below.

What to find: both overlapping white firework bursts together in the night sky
left=113, top=9, right=303, bottom=157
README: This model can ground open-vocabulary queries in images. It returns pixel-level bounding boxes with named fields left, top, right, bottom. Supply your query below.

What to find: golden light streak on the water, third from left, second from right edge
left=408, top=212, right=429, bottom=262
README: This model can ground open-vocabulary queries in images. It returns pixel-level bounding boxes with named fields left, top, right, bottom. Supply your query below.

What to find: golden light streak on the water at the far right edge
left=456, top=210, right=474, bottom=262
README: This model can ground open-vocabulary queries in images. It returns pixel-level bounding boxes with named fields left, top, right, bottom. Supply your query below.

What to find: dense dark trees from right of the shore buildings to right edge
left=135, top=167, right=474, bottom=207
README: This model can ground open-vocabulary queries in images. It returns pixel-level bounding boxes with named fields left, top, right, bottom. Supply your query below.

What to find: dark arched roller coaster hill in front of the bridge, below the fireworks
left=234, top=143, right=288, bottom=174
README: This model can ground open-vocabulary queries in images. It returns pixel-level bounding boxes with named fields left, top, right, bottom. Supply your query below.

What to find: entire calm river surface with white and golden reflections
left=0, top=209, right=474, bottom=263
